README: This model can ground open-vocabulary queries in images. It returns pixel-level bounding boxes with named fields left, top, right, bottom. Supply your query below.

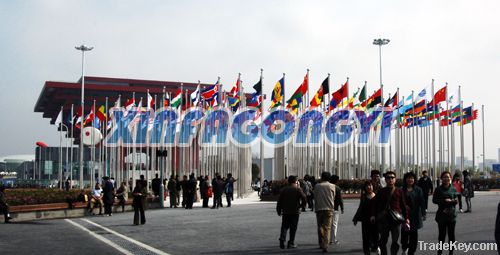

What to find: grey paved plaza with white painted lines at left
left=0, top=192, right=500, bottom=255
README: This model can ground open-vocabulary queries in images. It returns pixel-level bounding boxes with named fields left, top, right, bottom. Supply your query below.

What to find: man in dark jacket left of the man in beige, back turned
left=276, top=175, right=307, bottom=249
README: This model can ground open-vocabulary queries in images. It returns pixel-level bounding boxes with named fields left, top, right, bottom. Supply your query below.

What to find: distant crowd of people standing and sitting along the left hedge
left=76, top=173, right=237, bottom=225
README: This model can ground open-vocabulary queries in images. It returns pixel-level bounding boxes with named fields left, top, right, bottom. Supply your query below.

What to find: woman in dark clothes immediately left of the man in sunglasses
left=352, top=181, right=378, bottom=255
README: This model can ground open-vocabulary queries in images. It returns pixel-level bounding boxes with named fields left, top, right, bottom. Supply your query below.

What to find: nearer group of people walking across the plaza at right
left=276, top=170, right=474, bottom=255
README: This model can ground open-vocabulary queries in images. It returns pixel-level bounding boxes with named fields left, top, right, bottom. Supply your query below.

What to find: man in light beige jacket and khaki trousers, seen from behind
left=314, top=172, right=335, bottom=252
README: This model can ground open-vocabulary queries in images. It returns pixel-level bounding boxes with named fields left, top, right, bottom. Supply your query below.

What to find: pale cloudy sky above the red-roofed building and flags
left=0, top=0, right=500, bottom=159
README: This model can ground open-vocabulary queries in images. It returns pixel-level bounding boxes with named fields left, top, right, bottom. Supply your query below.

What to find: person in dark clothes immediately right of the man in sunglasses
left=401, top=172, right=425, bottom=255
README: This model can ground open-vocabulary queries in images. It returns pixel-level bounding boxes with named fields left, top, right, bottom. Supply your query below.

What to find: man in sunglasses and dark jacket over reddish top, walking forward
left=372, top=171, right=409, bottom=255
